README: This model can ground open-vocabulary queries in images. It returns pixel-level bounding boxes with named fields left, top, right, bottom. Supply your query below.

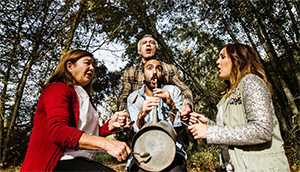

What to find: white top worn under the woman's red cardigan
left=60, top=86, right=99, bottom=160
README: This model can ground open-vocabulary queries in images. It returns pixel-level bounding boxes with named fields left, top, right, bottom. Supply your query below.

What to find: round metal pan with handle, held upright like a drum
left=132, top=105, right=177, bottom=171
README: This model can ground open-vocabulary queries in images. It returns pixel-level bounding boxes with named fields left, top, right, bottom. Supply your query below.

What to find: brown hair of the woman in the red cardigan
left=42, top=50, right=95, bottom=95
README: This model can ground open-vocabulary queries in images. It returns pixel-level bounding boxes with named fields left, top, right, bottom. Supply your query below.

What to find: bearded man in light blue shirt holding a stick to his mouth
left=127, top=59, right=186, bottom=172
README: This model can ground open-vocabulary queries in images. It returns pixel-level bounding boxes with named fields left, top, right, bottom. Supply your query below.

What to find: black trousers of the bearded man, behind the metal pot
left=127, top=154, right=187, bottom=172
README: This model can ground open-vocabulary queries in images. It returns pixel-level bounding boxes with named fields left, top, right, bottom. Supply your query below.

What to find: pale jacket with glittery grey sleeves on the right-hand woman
left=207, top=74, right=290, bottom=172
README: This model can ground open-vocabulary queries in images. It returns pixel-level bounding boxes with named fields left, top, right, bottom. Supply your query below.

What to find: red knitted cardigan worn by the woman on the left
left=21, top=82, right=112, bottom=172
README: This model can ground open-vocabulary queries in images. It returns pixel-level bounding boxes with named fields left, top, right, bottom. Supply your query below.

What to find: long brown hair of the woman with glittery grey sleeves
left=218, top=43, right=272, bottom=98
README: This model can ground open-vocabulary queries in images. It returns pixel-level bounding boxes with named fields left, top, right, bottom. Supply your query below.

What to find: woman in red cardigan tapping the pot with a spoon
left=21, top=50, right=131, bottom=172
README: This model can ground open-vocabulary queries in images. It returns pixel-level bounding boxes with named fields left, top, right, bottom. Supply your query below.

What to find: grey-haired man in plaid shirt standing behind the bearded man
left=118, top=35, right=193, bottom=120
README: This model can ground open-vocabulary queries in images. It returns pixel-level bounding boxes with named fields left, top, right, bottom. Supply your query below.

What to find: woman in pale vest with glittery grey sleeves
left=188, top=43, right=290, bottom=172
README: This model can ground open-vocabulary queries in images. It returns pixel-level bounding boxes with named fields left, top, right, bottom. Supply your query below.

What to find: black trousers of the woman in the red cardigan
left=53, top=158, right=115, bottom=172
